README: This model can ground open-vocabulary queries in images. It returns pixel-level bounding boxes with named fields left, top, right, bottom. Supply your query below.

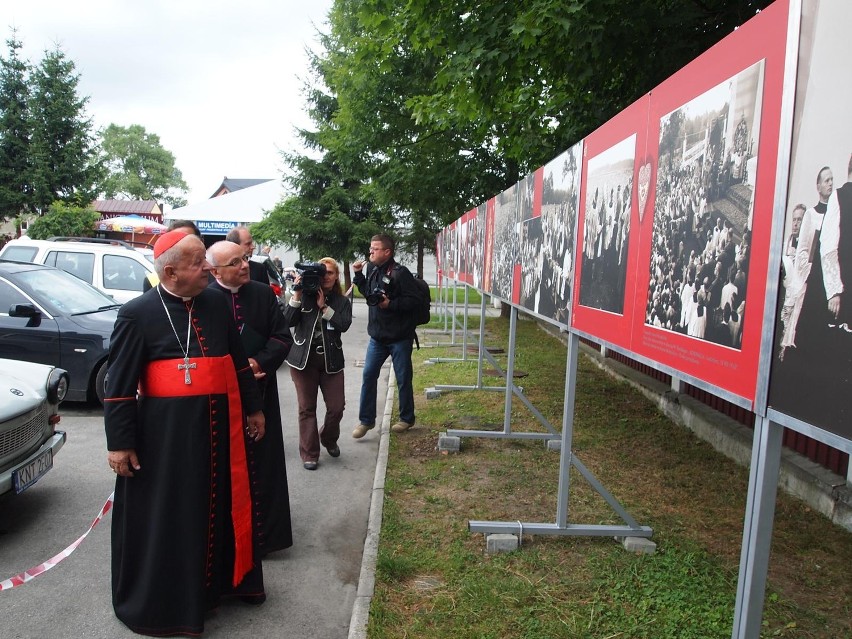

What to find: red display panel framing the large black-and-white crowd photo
left=630, top=2, right=788, bottom=404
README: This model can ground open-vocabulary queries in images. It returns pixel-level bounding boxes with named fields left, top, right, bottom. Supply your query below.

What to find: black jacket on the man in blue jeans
left=352, top=258, right=419, bottom=344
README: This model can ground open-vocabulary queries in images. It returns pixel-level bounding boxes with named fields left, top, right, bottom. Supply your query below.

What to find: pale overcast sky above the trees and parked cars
left=0, top=0, right=332, bottom=204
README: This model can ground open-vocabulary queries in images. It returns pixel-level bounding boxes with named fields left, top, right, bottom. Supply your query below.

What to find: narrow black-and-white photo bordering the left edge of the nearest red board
left=533, top=143, right=582, bottom=326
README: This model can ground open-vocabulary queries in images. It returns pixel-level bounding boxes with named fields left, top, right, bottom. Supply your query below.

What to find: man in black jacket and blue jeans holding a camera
left=352, top=234, right=418, bottom=439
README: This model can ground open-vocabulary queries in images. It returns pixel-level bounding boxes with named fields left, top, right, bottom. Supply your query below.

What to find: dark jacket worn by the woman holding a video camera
left=284, top=294, right=352, bottom=373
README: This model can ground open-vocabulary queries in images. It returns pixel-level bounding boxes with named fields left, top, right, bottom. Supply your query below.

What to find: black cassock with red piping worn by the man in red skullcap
left=104, top=286, right=265, bottom=636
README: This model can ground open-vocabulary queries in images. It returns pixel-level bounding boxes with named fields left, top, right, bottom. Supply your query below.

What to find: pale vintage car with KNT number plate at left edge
left=0, top=359, right=68, bottom=495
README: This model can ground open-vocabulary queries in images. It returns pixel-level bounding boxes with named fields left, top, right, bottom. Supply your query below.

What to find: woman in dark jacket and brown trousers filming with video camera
left=284, top=257, right=352, bottom=470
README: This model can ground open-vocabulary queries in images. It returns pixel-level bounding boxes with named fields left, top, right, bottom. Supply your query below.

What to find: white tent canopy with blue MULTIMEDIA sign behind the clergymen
left=165, top=180, right=284, bottom=235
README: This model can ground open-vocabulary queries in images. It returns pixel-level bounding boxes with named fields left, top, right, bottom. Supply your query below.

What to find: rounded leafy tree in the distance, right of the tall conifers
left=100, top=124, right=188, bottom=208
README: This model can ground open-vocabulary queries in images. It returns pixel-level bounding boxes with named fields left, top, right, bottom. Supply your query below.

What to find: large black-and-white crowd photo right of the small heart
left=645, top=61, right=764, bottom=350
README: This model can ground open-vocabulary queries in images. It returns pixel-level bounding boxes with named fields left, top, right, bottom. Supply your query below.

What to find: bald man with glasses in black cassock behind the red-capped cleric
left=207, top=241, right=293, bottom=557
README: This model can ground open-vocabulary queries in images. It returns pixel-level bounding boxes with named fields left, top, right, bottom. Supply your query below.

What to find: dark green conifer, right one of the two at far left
left=30, top=48, right=101, bottom=211
